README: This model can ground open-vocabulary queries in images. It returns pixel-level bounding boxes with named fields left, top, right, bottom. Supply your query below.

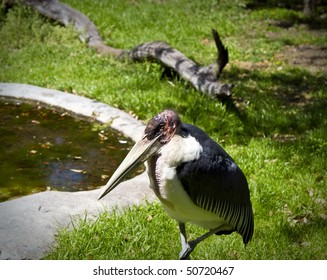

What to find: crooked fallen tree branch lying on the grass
left=5, top=0, right=232, bottom=99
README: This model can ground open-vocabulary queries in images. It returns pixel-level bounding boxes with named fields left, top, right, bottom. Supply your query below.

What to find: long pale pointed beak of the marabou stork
left=98, top=136, right=160, bottom=200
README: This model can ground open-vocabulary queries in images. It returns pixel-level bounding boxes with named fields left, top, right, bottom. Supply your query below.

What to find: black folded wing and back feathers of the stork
left=177, top=124, right=254, bottom=244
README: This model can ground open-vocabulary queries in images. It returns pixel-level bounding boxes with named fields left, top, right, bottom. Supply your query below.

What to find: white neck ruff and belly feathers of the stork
left=147, top=135, right=231, bottom=229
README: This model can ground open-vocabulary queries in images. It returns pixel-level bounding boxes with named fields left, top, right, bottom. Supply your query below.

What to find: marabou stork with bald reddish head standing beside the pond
left=98, top=110, right=254, bottom=259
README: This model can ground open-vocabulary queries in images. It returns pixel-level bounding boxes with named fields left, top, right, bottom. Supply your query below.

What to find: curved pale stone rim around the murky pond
left=0, top=83, right=155, bottom=259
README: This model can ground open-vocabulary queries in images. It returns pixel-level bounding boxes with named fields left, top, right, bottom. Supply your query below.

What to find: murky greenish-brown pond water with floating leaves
left=0, top=98, right=141, bottom=202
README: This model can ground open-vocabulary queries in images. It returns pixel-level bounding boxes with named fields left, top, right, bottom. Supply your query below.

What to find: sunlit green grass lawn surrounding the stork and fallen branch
left=0, top=0, right=327, bottom=259
